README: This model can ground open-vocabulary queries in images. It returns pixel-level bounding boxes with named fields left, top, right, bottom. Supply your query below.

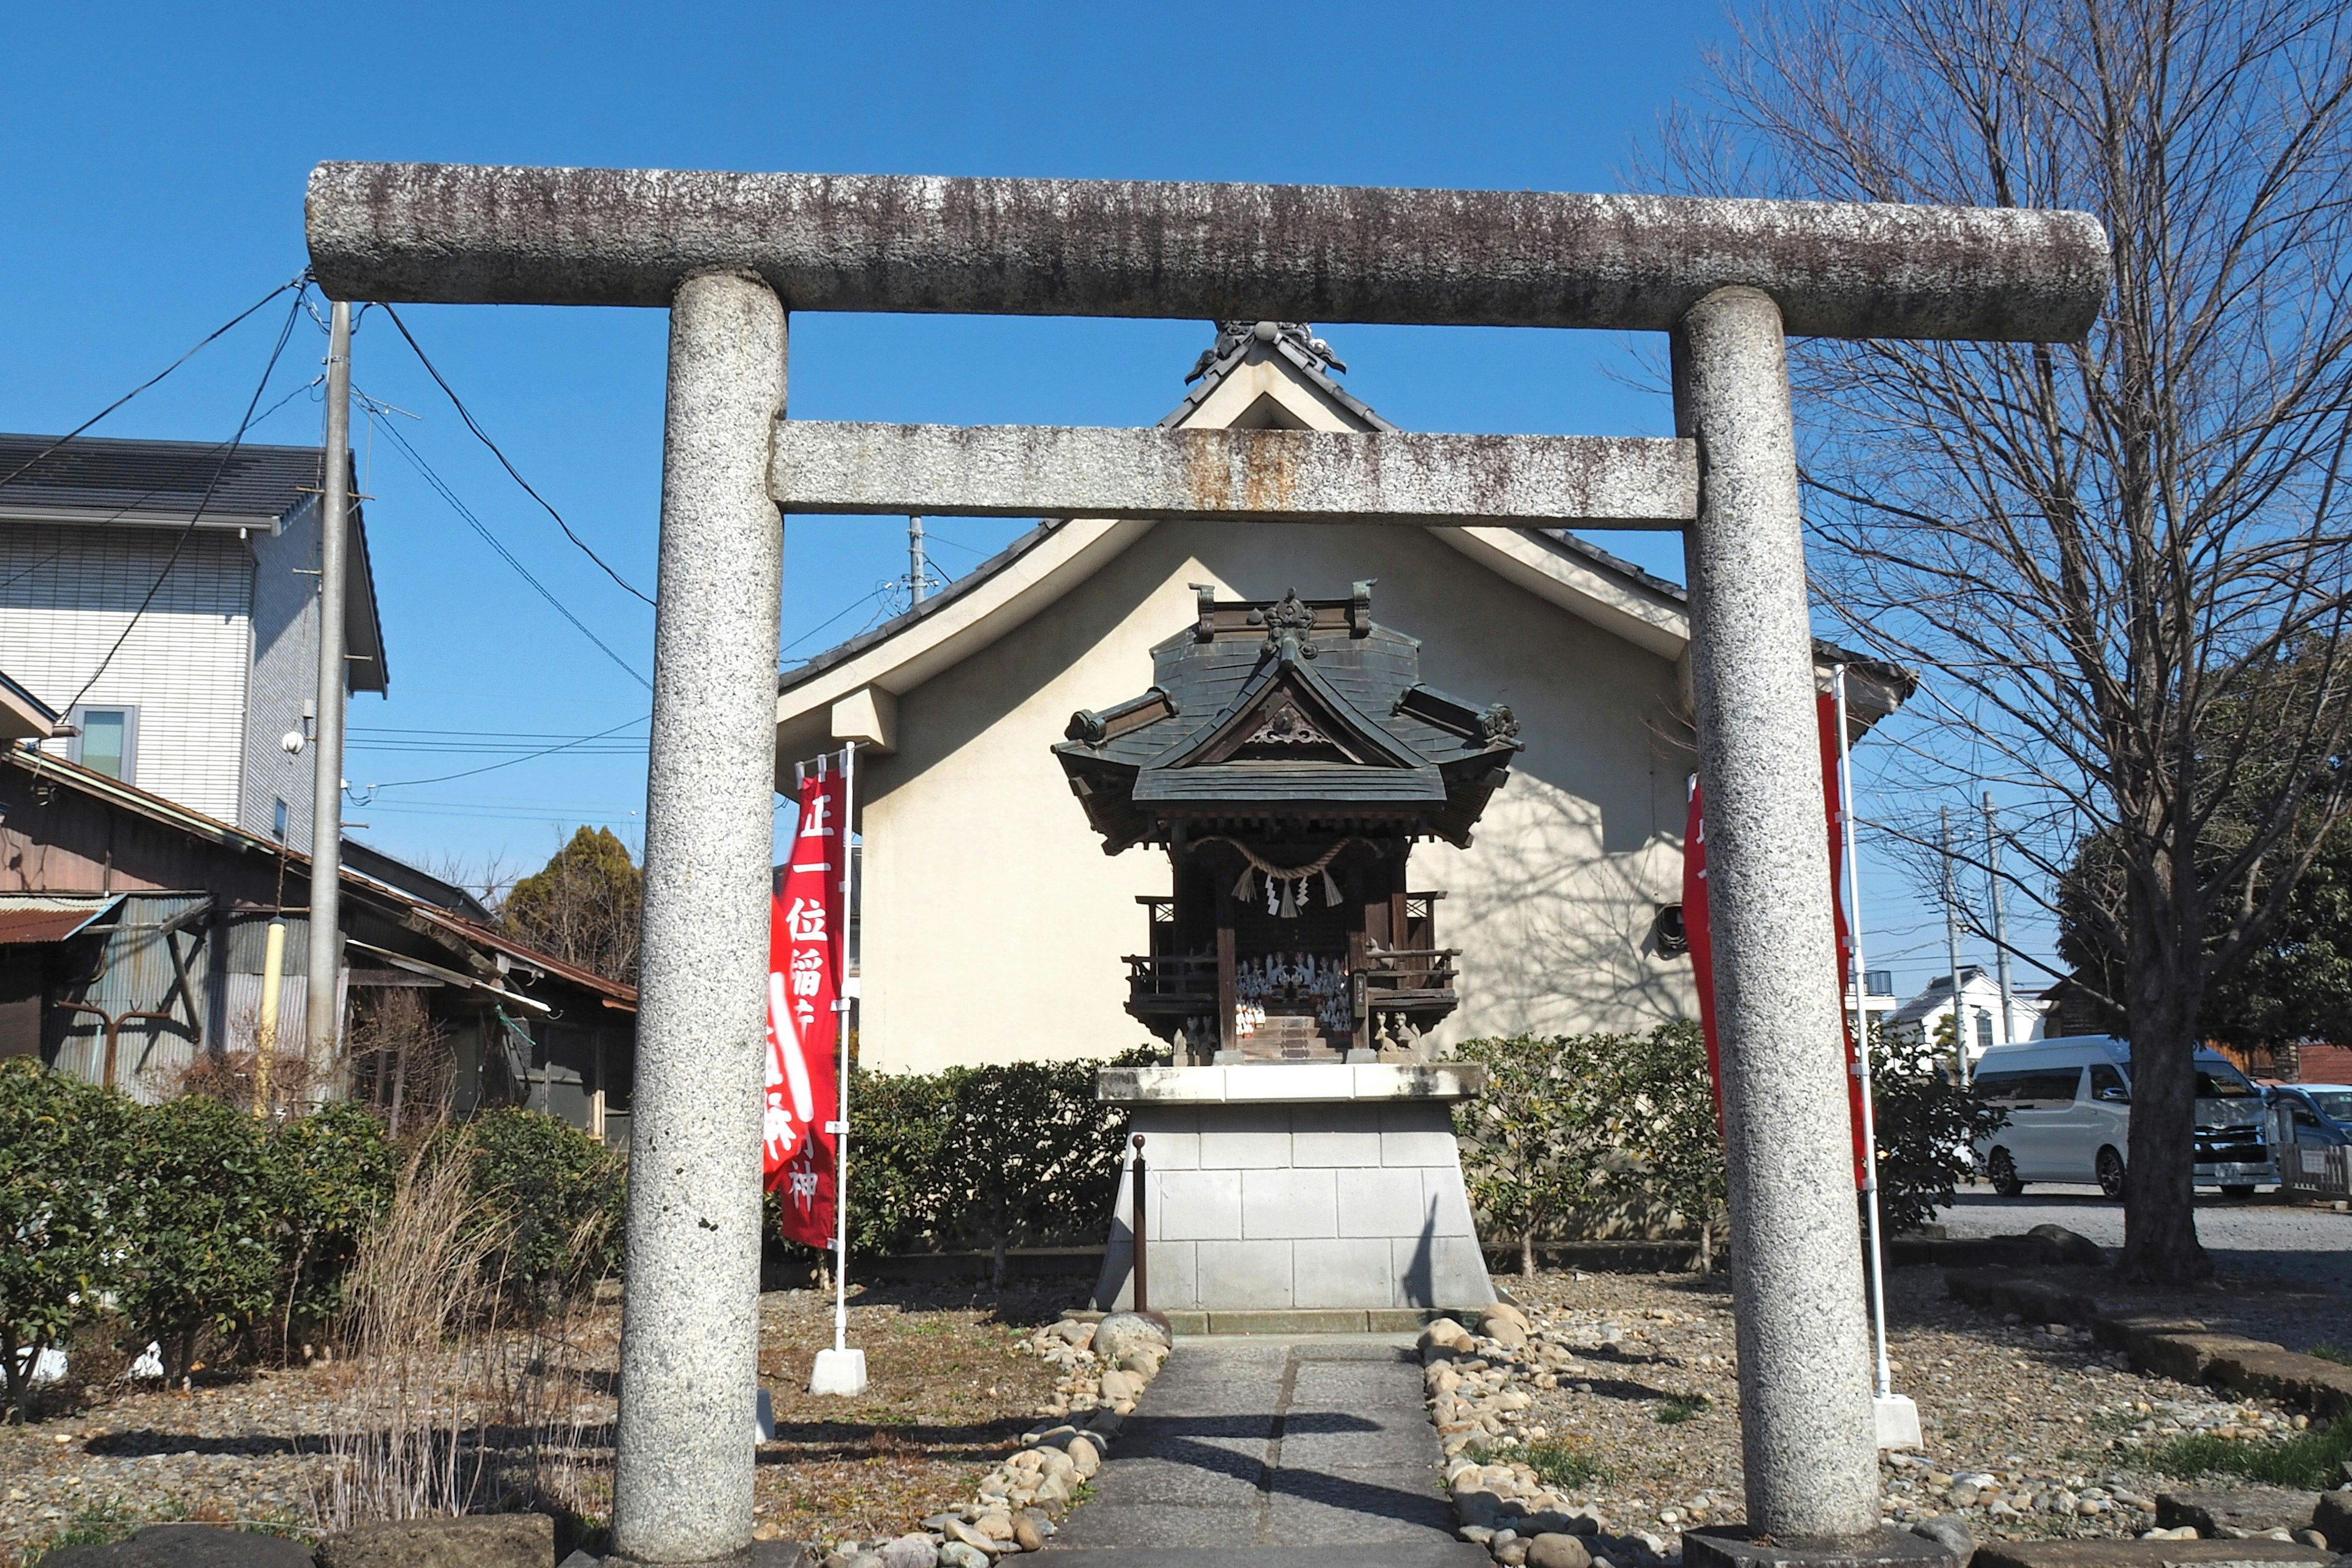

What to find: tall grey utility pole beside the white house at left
left=303, top=301, right=350, bottom=1105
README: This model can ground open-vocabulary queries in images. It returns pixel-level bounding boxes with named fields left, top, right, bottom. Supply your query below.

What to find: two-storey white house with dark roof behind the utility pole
left=0, top=435, right=386, bottom=844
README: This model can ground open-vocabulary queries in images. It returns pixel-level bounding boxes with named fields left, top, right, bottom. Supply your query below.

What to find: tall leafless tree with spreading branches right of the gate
left=1663, top=0, right=2352, bottom=1279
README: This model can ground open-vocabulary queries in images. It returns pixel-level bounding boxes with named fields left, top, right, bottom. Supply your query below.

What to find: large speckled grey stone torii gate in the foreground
left=308, top=162, right=2108, bottom=1563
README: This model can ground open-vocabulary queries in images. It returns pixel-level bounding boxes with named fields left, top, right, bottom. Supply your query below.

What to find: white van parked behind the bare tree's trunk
left=1976, top=1035, right=2279, bottom=1199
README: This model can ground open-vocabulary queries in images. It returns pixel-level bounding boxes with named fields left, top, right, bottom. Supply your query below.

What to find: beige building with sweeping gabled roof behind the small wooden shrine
left=776, top=322, right=1910, bottom=1069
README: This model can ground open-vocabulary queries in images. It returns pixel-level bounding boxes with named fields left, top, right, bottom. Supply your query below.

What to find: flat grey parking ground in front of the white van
left=1938, top=1183, right=2352, bottom=1297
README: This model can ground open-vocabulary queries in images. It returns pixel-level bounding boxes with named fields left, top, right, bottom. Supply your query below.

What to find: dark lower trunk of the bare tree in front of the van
left=2122, top=944, right=2213, bottom=1284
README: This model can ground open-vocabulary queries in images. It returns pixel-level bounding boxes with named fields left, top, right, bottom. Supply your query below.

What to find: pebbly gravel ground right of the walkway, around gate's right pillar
left=1449, top=1270, right=2340, bottom=1556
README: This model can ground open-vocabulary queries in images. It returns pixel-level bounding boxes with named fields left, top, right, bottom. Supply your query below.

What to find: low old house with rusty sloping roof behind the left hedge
left=0, top=742, right=638, bottom=1142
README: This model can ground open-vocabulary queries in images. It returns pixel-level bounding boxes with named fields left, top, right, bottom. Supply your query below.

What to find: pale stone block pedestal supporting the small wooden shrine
left=1094, top=1063, right=1493, bottom=1312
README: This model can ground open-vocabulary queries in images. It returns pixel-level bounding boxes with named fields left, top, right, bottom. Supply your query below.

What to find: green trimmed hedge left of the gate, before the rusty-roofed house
left=0, top=1058, right=624, bottom=1420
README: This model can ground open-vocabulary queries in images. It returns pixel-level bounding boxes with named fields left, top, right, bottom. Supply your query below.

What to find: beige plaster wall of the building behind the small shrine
left=861, top=524, right=1694, bottom=1072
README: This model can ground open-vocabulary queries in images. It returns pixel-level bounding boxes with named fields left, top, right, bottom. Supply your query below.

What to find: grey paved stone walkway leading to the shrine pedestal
left=1044, top=1335, right=1487, bottom=1568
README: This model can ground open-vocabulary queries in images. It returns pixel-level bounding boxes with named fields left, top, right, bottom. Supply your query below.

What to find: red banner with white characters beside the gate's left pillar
left=762, top=774, right=849, bottom=1246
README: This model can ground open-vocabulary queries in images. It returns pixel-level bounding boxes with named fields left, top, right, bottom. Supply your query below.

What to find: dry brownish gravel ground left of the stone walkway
left=0, top=1284, right=1070, bottom=1568
